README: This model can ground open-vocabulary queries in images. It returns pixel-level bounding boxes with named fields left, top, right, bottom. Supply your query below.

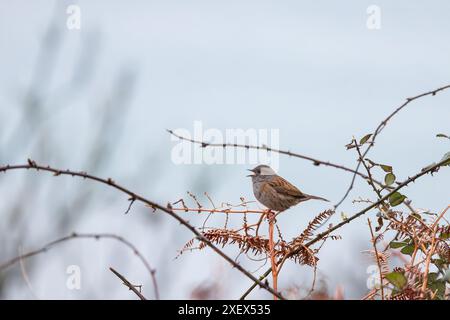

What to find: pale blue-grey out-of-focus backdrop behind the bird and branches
left=0, top=0, right=450, bottom=299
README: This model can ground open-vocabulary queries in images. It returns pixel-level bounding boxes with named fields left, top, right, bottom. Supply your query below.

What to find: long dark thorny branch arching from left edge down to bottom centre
left=0, top=159, right=284, bottom=299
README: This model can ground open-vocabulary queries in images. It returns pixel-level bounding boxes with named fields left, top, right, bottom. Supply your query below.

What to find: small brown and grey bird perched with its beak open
left=248, top=165, right=328, bottom=211
